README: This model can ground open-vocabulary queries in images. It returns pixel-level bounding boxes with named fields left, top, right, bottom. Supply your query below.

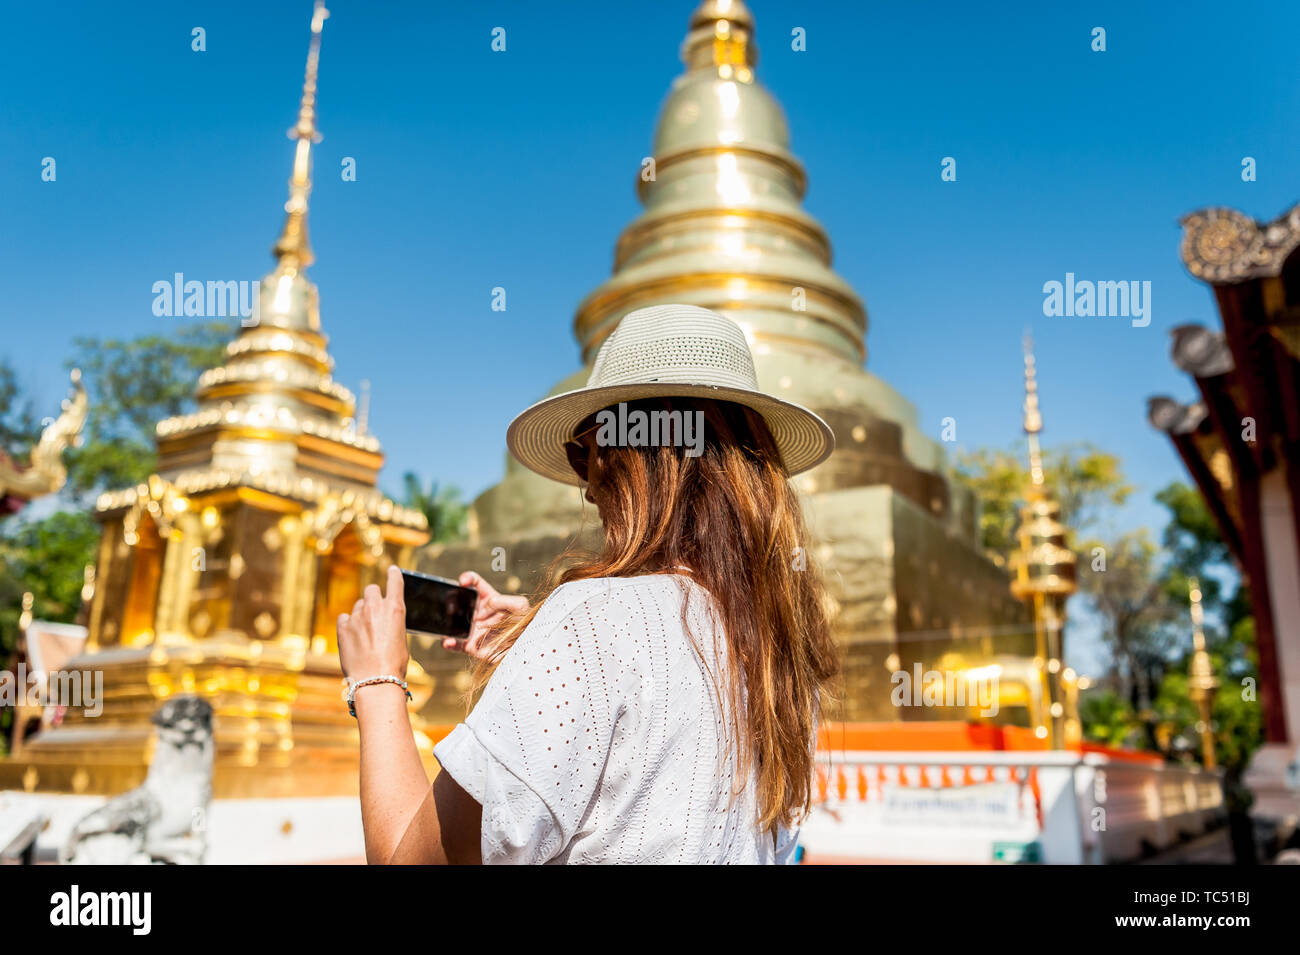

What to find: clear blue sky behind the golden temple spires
left=0, top=0, right=1300, bottom=670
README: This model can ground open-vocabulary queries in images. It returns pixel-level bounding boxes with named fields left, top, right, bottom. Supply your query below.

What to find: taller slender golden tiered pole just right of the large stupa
left=1010, top=335, right=1079, bottom=750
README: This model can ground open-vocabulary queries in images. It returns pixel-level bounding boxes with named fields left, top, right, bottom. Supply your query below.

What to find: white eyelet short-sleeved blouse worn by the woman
left=434, top=574, right=797, bottom=864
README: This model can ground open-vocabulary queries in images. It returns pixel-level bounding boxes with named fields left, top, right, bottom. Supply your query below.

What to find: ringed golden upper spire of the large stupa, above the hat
left=575, top=0, right=867, bottom=369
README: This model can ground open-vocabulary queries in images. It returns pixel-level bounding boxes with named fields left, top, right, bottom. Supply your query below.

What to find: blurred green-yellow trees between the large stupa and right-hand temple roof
left=957, top=444, right=1261, bottom=779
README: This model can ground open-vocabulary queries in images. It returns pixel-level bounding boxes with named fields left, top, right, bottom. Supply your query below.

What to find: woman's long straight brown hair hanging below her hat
left=471, top=398, right=839, bottom=830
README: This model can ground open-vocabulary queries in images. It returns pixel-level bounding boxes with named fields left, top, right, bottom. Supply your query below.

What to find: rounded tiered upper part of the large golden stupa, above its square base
left=471, top=0, right=974, bottom=539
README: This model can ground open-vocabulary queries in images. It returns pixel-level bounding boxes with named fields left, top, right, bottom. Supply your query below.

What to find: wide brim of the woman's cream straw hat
left=506, top=382, right=835, bottom=487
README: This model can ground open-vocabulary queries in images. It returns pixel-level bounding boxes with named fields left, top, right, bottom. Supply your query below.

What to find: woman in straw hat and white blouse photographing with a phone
left=338, top=305, right=837, bottom=863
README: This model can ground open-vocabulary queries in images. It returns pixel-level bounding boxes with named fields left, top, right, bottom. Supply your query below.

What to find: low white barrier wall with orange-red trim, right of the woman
left=800, top=751, right=1223, bottom=864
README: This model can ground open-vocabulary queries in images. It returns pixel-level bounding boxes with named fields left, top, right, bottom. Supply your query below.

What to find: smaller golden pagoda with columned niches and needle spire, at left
left=0, top=0, right=433, bottom=798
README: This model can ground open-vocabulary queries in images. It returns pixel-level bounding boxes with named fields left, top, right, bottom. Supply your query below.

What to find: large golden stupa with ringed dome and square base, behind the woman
left=420, top=0, right=1034, bottom=721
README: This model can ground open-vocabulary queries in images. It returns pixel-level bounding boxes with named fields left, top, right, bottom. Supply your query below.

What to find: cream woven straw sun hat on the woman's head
left=506, top=305, right=835, bottom=486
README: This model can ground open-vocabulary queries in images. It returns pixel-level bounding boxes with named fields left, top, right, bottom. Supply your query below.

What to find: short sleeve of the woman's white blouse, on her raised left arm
left=434, top=581, right=618, bottom=864
